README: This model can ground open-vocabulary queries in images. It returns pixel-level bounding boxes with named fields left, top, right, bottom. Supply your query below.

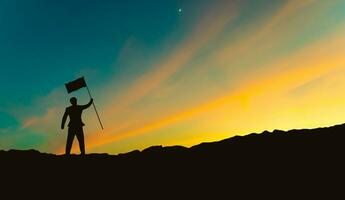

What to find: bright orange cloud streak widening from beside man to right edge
left=80, top=22, right=345, bottom=152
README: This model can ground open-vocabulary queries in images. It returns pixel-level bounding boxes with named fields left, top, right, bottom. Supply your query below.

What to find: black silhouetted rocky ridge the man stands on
left=0, top=124, right=345, bottom=199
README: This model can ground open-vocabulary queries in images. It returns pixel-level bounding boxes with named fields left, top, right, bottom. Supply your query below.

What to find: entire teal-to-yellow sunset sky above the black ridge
left=0, top=0, right=345, bottom=154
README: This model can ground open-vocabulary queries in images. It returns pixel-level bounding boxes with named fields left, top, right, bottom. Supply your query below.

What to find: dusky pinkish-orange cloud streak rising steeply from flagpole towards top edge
left=101, top=3, right=237, bottom=115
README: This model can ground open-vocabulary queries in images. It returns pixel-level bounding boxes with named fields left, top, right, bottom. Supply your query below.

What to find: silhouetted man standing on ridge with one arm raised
left=61, top=97, right=93, bottom=155
